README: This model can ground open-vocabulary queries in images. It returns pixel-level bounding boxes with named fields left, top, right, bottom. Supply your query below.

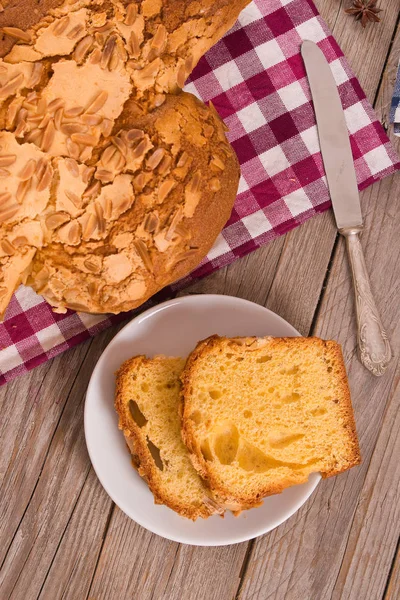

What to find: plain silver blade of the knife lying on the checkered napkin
left=301, top=40, right=363, bottom=229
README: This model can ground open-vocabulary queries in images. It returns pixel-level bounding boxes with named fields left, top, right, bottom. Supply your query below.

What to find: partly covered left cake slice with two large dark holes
left=115, top=356, right=223, bottom=520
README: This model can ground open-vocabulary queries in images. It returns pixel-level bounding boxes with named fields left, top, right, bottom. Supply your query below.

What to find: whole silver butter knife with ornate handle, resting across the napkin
left=301, top=40, right=392, bottom=375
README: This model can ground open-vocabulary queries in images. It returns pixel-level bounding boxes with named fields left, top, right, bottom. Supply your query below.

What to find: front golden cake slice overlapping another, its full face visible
left=182, top=336, right=360, bottom=508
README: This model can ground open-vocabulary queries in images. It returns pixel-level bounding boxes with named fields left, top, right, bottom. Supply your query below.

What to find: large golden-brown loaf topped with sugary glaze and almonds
left=0, top=0, right=248, bottom=313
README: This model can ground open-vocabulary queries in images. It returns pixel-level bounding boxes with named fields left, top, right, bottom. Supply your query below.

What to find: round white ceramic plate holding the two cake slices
left=85, top=294, right=320, bottom=546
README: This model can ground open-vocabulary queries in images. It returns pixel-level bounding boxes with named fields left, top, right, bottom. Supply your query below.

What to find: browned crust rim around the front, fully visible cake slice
left=181, top=335, right=361, bottom=510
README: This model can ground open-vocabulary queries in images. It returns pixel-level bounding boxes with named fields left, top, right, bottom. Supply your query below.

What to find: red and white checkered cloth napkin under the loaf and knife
left=0, top=0, right=400, bottom=383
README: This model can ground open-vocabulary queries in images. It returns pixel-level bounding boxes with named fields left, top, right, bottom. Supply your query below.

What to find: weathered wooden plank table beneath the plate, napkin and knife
left=0, top=0, right=400, bottom=600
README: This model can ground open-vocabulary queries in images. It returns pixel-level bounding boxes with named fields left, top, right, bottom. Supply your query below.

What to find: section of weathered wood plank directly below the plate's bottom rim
left=89, top=508, right=246, bottom=600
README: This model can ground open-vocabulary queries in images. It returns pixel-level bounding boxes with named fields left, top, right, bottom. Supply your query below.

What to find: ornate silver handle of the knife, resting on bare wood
left=339, top=227, right=392, bottom=376
